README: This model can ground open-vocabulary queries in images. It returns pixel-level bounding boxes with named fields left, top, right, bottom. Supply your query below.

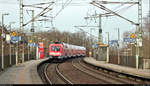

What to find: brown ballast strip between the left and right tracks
left=59, top=59, right=108, bottom=84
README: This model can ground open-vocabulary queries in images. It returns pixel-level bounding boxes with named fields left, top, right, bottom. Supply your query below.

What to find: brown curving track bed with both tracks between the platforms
left=39, top=59, right=147, bottom=84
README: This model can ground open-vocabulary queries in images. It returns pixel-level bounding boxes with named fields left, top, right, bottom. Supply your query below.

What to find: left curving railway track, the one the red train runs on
left=38, top=61, right=73, bottom=84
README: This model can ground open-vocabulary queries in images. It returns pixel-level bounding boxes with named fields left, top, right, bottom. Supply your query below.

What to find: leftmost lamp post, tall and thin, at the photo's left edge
left=2, top=13, right=9, bottom=70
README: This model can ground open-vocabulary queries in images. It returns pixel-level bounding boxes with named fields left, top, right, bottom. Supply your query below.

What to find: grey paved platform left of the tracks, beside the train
left=0, top=59, right=46, bottom=84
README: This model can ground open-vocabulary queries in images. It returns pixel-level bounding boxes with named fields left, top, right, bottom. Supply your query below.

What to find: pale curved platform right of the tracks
left=83, top=57, right=150, bottom=79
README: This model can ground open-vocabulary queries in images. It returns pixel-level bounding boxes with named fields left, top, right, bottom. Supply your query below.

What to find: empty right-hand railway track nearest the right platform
left=72, top=60, right=145, bottom=84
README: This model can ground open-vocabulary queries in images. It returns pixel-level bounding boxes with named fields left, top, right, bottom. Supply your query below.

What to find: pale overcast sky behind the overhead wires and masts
left=0, top=0, right=149, bottom=43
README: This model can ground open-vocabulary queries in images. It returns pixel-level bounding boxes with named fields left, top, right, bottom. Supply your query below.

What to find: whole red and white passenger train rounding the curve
left=49, top=42, right=86, bottom=59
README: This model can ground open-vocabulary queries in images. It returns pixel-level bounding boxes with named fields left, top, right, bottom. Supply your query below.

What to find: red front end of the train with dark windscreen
left=49, top=44, right=63, bottom=60
